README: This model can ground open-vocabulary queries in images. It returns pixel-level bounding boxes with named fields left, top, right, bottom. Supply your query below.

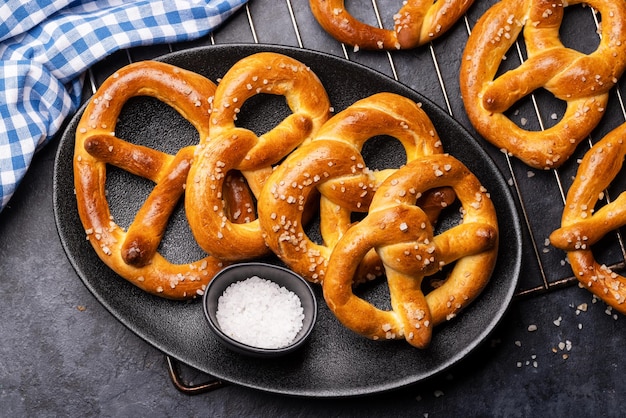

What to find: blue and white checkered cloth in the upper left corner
left=0, top=0, right=247, bottom=212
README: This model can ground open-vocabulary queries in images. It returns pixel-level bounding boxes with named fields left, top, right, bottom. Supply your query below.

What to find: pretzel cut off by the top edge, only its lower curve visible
left=309, top=0, right=474, bottom=50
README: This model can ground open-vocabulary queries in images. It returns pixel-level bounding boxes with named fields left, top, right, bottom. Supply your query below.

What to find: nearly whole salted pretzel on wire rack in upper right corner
left=460, top=0, right=626, bottom=169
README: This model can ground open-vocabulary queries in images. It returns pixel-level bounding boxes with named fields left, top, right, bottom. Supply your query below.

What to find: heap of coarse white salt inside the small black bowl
left=216, top=276, right=304, bottom=348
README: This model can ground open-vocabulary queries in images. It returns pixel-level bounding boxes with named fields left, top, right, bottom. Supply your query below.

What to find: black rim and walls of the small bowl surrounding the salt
left=203, top=262, right=317, bottom=357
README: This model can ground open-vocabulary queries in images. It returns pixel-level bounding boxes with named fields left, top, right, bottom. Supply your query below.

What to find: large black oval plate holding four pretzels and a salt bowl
left=54, top=44, right=522, bottom=397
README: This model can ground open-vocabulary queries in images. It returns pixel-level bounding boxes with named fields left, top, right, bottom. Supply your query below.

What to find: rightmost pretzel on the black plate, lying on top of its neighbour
left=322, top=154, right=498, bottom=348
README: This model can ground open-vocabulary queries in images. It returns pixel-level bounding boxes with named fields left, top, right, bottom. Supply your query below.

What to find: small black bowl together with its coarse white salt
left=203, top=262, right=317, bottom=357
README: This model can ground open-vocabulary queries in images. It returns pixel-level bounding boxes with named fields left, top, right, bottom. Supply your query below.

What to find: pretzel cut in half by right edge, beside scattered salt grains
left=550, top=124, right=626, bottom=314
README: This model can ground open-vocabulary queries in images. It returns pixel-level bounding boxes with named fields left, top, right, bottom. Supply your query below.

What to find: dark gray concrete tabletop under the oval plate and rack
left=0, top=0, right=626, bottom=417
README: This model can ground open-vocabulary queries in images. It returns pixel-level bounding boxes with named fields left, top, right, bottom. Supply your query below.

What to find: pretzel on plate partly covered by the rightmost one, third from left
left=258, top=93, right=450, bottom=283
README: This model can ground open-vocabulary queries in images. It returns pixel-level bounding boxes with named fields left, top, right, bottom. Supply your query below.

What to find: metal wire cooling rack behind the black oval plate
left=80, top=0, right=626, bottom=394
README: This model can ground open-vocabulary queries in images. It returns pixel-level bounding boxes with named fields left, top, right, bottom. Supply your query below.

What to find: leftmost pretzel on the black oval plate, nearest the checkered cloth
left=74, top=61, right=244, bottom=299
